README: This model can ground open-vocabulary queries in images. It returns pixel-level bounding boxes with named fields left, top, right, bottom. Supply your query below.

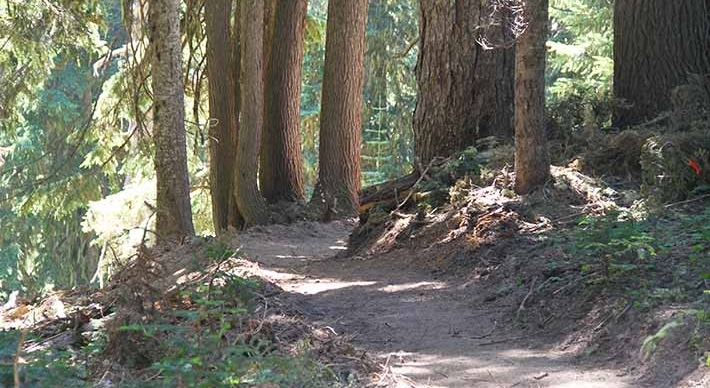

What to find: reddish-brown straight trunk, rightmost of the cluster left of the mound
left=312, top=0, right=367, bottom=220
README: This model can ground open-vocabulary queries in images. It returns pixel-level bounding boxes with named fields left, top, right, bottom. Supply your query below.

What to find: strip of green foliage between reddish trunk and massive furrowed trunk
left=362, top=0, right=419, bottom=185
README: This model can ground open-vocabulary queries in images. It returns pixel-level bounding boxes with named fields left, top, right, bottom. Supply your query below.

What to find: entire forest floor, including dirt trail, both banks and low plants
left=0, top=167, right=710, bottom=388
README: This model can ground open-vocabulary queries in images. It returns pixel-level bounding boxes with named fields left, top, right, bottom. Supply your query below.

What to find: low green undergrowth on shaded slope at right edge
left=561, top=209, right=710, bottom=310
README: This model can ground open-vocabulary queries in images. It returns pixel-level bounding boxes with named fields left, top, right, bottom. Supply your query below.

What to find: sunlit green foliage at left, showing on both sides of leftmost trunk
left=0, top=0, right=218, bottom=295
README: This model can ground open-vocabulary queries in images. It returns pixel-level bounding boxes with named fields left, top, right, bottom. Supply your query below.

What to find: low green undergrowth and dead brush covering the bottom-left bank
left=0, top=244, right=355, bottom=388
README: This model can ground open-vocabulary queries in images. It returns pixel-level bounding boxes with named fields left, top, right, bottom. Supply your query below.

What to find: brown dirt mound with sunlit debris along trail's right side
left=350, top=165, right=710, bottom=387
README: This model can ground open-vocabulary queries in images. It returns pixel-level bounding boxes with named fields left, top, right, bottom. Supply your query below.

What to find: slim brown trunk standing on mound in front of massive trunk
left=515, top=0, right=550, bottom=194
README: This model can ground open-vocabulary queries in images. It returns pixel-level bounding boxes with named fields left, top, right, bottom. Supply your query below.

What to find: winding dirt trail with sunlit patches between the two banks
left=235, top=223, right=636, bottom=388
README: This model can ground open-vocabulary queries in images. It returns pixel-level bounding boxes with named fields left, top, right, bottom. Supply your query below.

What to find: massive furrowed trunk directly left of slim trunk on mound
left=413, top=0, right=514, bottom=167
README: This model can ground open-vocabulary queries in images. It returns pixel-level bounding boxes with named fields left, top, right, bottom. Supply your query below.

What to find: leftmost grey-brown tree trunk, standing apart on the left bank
left=148, top=0, right=195, bottom=241
